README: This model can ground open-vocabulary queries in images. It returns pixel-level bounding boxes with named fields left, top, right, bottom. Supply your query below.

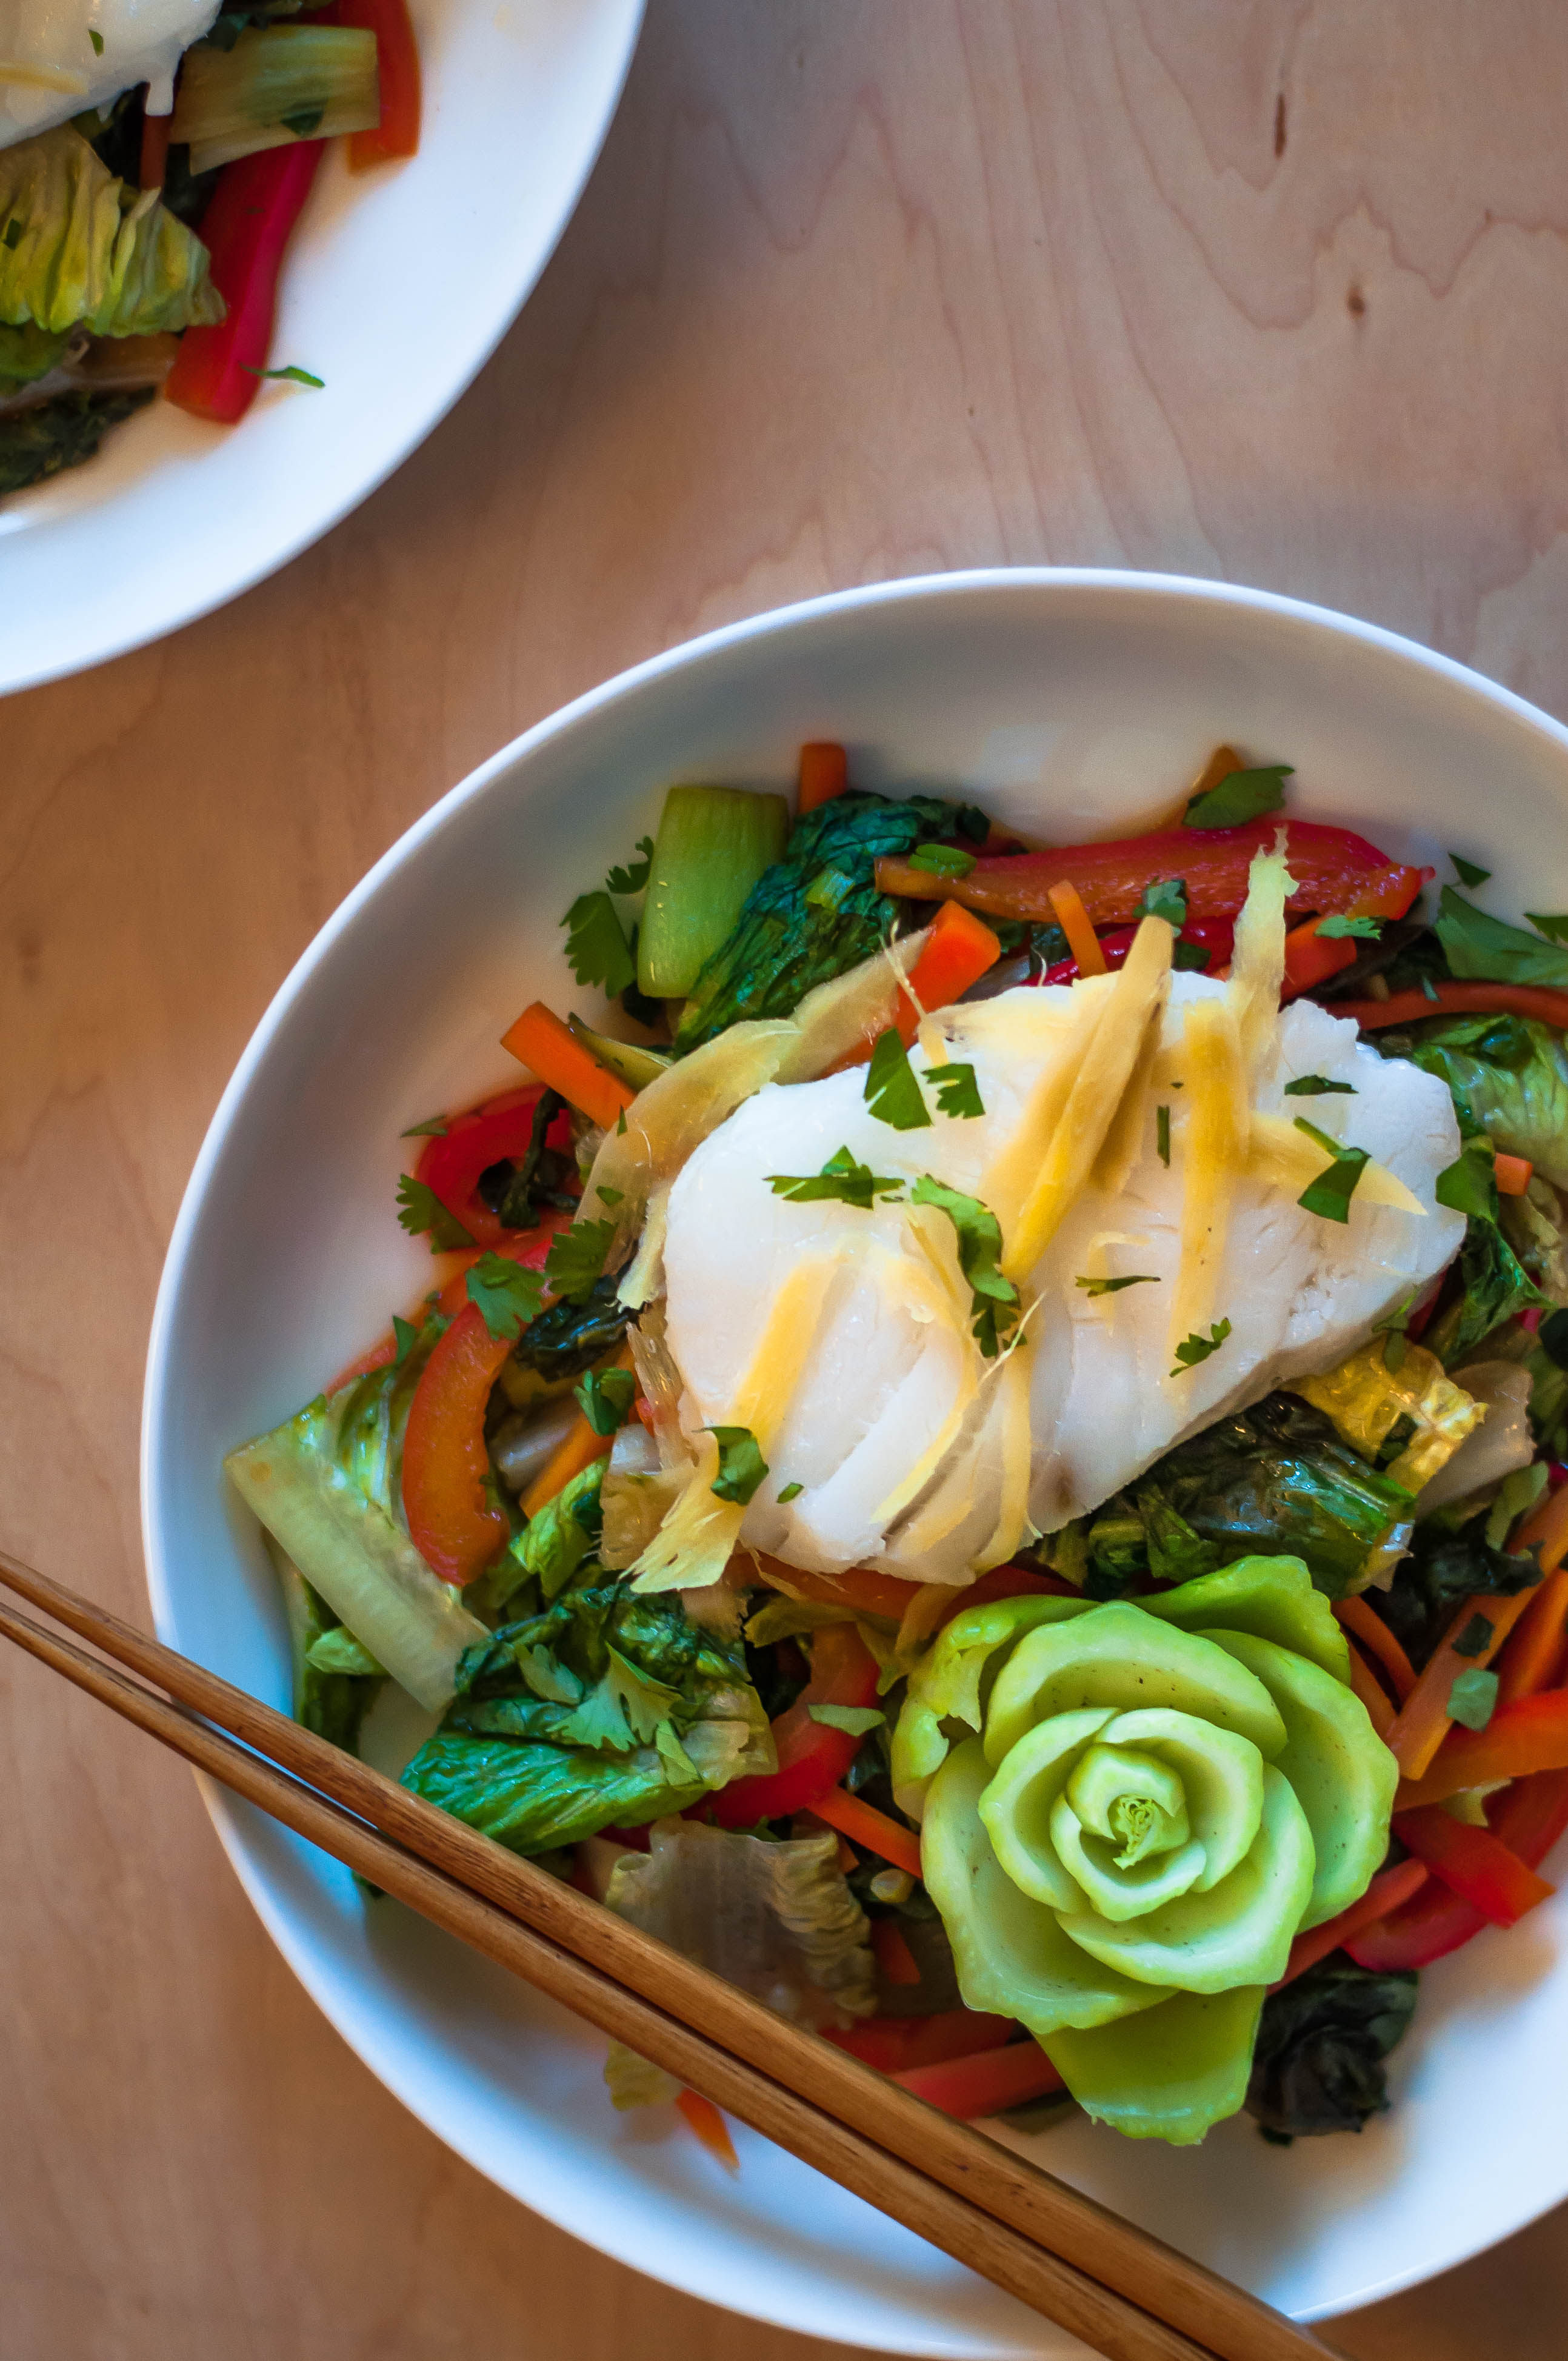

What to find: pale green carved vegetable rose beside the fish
left=893, top=1558, right=1398, bottom=2142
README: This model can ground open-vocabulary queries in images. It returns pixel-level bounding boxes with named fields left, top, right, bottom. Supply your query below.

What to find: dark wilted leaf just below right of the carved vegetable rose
left=1247, top=1950, right=1417, bottom=2142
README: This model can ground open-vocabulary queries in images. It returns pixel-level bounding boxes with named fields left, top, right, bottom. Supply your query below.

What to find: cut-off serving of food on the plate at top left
left=0, top=0, right=421, bottom=493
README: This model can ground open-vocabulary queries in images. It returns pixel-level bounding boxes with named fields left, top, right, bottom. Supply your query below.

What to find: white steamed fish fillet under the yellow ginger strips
left=664, top=975, right=1464, bottom=1585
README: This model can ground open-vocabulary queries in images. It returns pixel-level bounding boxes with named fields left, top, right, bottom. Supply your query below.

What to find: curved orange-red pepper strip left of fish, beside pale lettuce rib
left=404, top=1303, right=512, bottom=1585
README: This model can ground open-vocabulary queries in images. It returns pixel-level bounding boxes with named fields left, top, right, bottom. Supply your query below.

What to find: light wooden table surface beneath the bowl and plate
left=0, top=0, right=1568, bottom=2361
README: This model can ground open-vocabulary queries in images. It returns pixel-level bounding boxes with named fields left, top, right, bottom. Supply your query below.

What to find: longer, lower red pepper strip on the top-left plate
left=163, top=139, right=326, bottom=427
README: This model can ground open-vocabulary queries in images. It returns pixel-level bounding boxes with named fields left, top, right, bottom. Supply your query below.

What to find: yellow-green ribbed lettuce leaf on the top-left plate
left=0, top=123, right=224, bottom=335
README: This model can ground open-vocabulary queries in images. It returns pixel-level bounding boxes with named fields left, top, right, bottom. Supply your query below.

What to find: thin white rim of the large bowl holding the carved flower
left=139, top=567, right=1568, bottom=2354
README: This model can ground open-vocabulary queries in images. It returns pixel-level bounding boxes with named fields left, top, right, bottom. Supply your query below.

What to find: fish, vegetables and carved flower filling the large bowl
left=227, top=746, right=1568, bottom=2144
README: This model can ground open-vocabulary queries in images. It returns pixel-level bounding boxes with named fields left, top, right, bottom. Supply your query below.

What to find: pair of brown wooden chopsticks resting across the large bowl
left=0, top=1551, right=1327, bottom=2361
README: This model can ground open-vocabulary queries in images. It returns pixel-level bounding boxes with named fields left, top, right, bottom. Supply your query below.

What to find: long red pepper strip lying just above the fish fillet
left=876, top=815, right=1389, bottom=926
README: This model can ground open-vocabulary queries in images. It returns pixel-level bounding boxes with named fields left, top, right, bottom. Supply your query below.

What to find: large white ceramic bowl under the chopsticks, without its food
left=144, top=572, right=1568, bottom=2356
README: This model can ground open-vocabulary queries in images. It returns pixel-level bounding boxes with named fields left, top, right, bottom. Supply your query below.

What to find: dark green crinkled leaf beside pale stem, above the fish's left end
left=675, top=789, right=966, bottom=1053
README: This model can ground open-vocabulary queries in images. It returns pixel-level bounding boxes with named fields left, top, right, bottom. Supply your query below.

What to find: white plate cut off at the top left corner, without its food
left=0, top=0, right=642, bottom=694
